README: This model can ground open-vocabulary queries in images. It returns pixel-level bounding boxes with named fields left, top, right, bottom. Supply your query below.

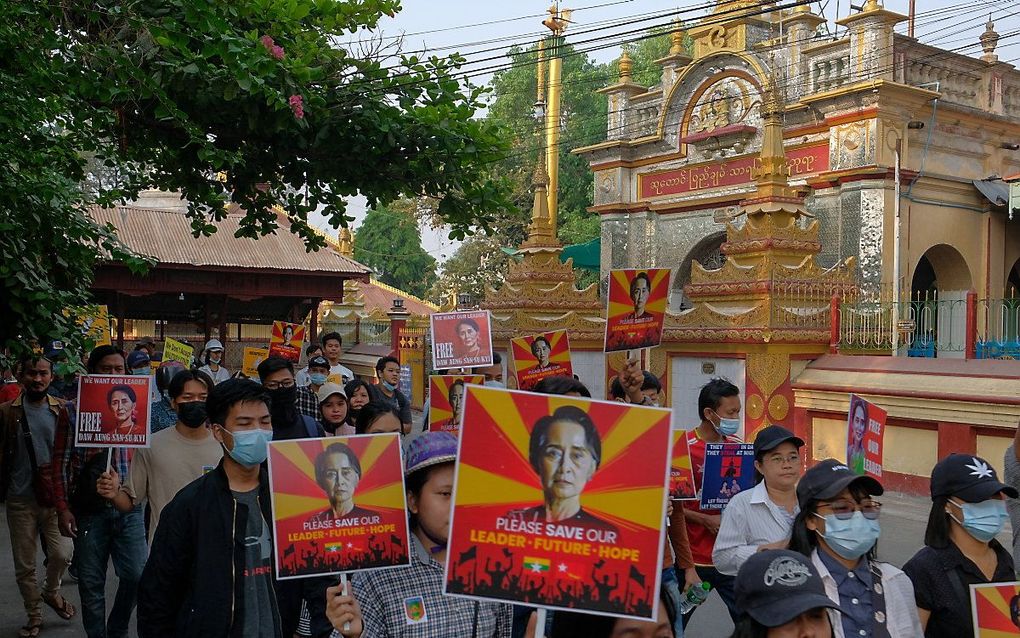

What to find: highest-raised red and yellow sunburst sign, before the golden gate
left=606, top=268, right=669, bottom=352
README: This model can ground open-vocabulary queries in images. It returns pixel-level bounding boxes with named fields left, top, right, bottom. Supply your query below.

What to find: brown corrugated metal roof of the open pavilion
left=88, top=206, right=370, bottom=279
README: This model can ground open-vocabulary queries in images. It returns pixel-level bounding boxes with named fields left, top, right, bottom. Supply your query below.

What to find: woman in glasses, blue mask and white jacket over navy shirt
left=789, top=458, right=921, bottom=638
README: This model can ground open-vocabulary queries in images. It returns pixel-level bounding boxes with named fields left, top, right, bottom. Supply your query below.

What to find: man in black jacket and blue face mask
left=138, top=379, right=283, bottom=638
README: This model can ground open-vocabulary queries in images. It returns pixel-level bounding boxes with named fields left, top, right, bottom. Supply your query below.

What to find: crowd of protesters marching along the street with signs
left=0, top=333, right=1020, bottom=638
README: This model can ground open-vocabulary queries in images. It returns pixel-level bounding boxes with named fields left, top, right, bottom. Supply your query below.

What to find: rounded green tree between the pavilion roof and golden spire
left=354, top=200, right=437, bottom=297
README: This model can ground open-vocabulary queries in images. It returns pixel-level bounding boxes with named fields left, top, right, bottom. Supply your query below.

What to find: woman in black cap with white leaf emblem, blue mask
left=903, top=454, right=1017, bottom=638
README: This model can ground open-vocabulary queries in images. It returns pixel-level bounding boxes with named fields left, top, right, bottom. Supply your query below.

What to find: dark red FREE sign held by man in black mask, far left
left=74, top=375, right=152, bottom=447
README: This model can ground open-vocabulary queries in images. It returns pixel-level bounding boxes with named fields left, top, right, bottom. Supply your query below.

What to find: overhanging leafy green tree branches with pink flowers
left=0, top=0, right=509, bottom=359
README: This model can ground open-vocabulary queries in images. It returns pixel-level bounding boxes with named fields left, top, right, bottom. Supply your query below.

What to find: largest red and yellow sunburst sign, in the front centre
left=446, top=386, right=672, bottom=619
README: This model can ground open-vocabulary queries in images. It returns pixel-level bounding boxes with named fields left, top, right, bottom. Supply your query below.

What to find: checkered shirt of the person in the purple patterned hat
left=330, top=534, right=513, bottom=638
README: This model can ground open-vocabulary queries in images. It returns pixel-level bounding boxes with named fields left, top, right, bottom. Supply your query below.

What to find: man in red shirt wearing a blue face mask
left=683, top=379, right=741, bottom=626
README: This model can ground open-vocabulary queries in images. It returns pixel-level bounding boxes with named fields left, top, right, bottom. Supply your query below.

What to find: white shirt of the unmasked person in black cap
left=712, top=481, right=801, bottom=576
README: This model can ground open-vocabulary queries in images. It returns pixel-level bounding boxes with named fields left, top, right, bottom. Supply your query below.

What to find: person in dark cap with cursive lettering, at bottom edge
left=732, top=549, right=843, bottom=638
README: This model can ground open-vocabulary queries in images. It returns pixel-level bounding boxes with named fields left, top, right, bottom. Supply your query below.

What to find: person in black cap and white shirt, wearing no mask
left=712, top=426, right=804, bottom=576
